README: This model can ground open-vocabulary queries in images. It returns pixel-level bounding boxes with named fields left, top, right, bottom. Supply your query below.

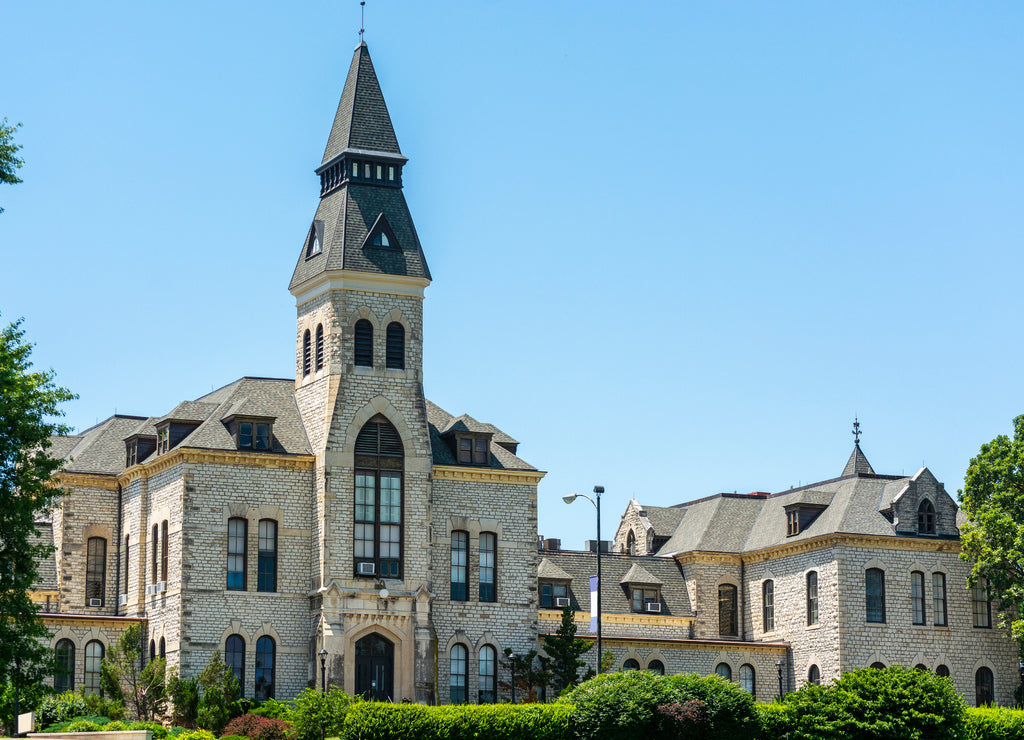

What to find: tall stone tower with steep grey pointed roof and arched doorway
left=289, top=42, right=433, bottom=701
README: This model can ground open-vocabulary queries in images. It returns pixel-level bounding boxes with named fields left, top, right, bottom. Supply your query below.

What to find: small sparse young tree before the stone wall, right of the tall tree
left=100, top=624, right=167, bottom=722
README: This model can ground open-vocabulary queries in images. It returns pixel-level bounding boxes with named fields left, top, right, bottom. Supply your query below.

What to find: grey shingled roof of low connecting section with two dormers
left=538, top=550, right=693, bottom=616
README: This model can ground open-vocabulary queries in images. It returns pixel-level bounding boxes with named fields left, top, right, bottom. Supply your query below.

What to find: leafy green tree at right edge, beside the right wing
left=959, top=416, right=1024, bottom=655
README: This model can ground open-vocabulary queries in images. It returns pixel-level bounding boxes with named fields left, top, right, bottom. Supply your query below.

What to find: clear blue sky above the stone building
left=0, top=0, right=1024, bottom=547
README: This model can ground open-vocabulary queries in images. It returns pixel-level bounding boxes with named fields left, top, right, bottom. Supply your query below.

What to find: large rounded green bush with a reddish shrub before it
left=559, top=670, right=761, bottom=740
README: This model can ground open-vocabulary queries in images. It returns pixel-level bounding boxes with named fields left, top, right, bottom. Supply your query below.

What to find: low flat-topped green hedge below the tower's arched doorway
left=340, top=701, right=572, bottom=740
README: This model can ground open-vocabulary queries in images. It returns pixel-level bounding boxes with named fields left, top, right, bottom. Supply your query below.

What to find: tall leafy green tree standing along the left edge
left=0, top=319, right=76, bottom=712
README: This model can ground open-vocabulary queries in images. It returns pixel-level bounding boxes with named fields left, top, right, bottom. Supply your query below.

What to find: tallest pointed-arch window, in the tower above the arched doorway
left=353, top=415, right=404, bottom=578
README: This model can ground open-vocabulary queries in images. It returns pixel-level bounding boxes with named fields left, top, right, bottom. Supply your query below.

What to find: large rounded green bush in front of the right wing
left=785, top=665, right=965, bottom=740
